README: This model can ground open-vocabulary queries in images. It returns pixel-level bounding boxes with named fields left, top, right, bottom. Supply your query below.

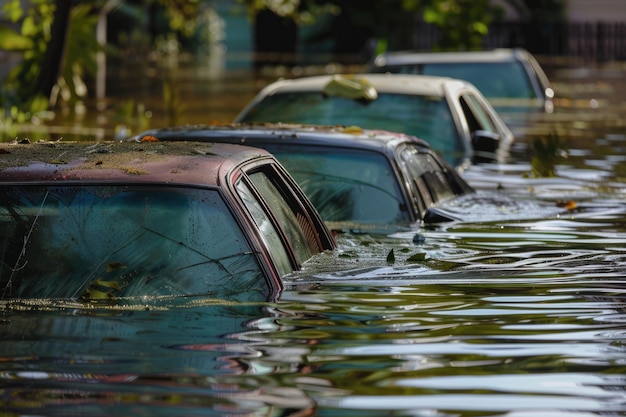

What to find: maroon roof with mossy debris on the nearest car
left=0, top=141, right=273, bottom=186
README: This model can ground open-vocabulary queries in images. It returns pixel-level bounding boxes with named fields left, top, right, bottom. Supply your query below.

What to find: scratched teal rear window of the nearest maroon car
left=0, top=185, right=269, bottom=301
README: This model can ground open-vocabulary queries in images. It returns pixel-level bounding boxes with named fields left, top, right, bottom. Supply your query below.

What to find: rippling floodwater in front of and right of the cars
left=0, top=57, right=626, bottom=417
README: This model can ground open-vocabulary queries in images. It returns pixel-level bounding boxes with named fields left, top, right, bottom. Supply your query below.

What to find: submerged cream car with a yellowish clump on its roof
left=235, top=74, right=513, bottom=169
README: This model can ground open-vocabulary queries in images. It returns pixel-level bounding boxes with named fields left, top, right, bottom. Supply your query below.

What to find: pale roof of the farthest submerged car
left=374, top=48, right=527, bottom=67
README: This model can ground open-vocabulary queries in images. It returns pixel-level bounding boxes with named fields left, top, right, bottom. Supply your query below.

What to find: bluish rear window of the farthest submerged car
left=385, top=62, right=537, bottom=99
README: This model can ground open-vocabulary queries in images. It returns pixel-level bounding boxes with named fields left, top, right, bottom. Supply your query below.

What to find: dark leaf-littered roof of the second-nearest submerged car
left=131, top=123, right=432, bottom=157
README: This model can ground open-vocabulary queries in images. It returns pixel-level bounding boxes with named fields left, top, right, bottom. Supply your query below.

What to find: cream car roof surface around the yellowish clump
left=246, top=73, right=471, bottom=97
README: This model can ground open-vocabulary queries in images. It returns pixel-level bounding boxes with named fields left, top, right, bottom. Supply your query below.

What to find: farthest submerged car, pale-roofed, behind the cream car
left=369, top=48, right=554, bottom=113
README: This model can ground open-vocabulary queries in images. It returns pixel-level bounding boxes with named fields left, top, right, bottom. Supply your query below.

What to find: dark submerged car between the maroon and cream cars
left=132, top=124, right=473, bottom=230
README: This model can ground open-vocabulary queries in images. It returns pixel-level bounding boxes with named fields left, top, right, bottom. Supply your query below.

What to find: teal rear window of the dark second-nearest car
left=258, top=145, right=410, bottom=225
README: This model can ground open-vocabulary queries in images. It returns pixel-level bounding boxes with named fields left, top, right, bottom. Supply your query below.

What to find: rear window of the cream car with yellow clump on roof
left=239, top=92, right=465, bottom=159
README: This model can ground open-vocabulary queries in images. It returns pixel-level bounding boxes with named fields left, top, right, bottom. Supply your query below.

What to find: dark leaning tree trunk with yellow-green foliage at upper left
left=0, top=0, right=98, bottom=119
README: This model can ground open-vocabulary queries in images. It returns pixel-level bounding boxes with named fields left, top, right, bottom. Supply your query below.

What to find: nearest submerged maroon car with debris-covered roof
left=0, top=142, right=335, bottom=302
